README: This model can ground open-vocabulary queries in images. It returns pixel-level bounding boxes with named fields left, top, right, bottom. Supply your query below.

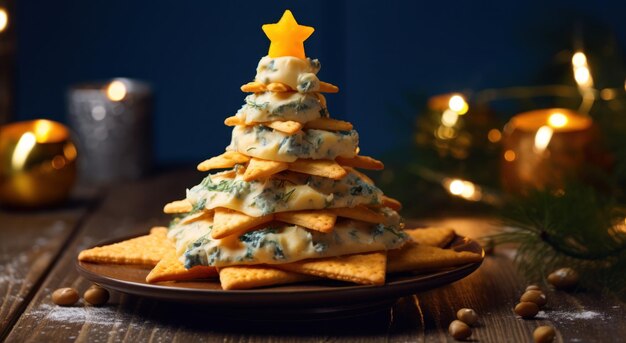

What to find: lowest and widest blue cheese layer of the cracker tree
left=174, top=220, right=408, bottom=268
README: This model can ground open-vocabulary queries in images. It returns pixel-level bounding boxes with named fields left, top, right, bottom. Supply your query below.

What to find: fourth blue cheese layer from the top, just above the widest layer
left=187, top=171, right=383, bottom=217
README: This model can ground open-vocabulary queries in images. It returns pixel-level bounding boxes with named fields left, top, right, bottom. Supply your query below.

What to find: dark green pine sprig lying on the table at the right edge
left=490, top=184, right=626, bottom=297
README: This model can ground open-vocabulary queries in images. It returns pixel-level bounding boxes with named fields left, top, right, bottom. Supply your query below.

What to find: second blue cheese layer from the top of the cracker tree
left=236, top=92, right=328, bottom=124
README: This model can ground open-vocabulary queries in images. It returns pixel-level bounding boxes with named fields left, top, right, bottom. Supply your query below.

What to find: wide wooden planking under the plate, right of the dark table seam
left=8, top=173, right=626, bottom=342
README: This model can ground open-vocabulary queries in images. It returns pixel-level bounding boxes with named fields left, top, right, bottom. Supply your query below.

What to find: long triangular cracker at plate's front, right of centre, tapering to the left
left=274, top=251, right=387, bottom=285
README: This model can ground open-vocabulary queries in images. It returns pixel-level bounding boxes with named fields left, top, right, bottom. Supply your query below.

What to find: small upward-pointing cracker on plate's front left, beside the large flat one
left=146, top=250, right=217, bottom=283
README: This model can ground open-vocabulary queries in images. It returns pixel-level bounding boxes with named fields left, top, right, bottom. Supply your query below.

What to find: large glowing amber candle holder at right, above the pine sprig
left=502, top=108, right=594, bottom=192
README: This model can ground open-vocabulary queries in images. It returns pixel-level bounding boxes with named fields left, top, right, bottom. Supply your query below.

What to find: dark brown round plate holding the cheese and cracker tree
left=76, top=234, right=484, bottom=306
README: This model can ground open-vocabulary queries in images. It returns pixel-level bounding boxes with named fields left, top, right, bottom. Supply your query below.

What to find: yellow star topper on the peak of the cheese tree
left=263, top=10, right=315, bottom=59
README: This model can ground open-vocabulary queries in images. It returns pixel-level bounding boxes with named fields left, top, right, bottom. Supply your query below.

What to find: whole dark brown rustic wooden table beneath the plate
left=0, top=172, right=626, bottom=342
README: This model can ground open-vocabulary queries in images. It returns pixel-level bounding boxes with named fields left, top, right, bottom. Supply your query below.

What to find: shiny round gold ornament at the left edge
left=0, top=119, right=77, bottom=208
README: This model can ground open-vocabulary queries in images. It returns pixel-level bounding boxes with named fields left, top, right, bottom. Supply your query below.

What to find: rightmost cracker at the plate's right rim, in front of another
left=387, top=243, right=482, bottom=273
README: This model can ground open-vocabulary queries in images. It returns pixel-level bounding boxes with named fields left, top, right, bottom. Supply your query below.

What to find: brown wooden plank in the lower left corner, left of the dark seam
left=0, top=205, right=87, bottom=339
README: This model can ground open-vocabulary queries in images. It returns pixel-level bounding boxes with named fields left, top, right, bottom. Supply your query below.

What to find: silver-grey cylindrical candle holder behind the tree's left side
left=68, top=78, right=152, bottom=184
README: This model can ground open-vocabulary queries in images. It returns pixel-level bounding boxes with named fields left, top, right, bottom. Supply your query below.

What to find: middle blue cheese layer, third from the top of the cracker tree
left=226, top=125, right=359, bottom=162
